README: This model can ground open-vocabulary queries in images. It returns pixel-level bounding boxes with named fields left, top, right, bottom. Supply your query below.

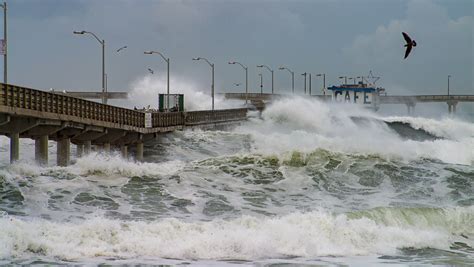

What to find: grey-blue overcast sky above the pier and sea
left=7, top=0, right=474, bottom=100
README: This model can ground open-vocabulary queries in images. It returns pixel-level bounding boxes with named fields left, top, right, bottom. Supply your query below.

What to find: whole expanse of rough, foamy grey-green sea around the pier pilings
left=0, top=99, right=474, bottom=266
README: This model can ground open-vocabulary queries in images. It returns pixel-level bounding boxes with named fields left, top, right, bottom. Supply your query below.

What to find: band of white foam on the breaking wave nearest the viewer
left=0, top=208, right=474, bottom=260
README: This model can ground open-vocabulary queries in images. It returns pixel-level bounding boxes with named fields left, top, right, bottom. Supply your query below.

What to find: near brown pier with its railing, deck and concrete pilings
left=0, top=83, right=247, bottom=166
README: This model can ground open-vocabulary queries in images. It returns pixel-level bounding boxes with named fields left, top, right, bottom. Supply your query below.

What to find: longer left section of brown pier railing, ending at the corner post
left=0, top=83, right=145, bottom=127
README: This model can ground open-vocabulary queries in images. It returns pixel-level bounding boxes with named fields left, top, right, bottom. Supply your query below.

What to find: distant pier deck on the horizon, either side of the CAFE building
left=223, top=93, right=474, bottom=113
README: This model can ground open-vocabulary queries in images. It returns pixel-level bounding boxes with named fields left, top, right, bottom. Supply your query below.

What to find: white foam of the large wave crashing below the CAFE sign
left=237, top=97, right=474, bottom=165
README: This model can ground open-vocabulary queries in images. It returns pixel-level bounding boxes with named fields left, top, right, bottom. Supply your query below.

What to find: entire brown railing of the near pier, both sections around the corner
left=0, top=83, right=247, bottom=128
